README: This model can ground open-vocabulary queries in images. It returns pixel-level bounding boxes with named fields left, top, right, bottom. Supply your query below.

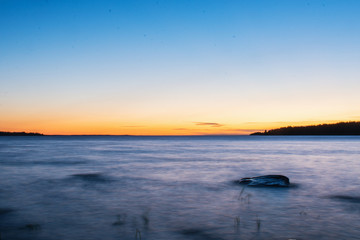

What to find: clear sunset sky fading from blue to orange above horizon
left=0, top=0, right=360, bottom=135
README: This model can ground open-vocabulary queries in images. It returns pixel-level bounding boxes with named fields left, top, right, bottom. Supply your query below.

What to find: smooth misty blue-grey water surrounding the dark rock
left=0, top=136, right=360, bottom=240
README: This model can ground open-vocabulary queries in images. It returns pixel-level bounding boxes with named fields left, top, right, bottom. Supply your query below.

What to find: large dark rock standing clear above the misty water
left=235, top=175, right=290, bottom=187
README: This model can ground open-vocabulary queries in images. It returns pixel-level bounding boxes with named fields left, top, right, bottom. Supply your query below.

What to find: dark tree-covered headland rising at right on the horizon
left=250, top=122, right=360, bottom=136
